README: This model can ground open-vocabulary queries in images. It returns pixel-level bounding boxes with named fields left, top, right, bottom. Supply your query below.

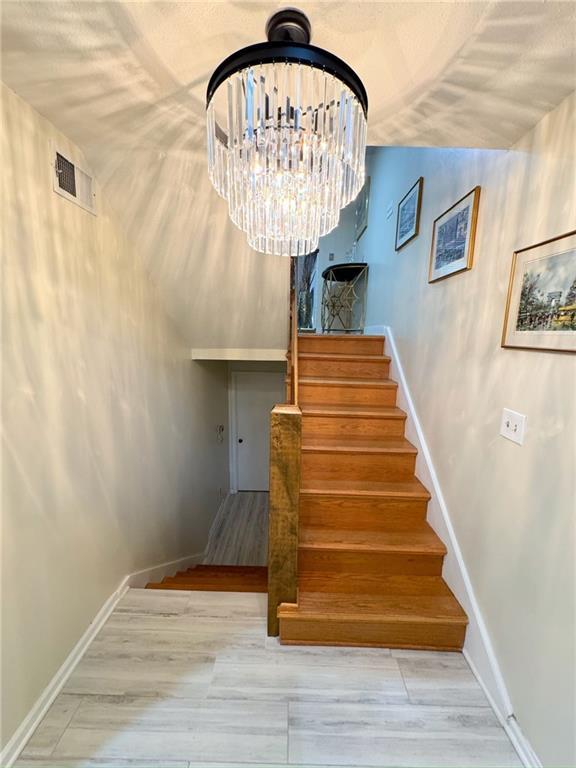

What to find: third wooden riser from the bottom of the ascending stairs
left=299, top=494, right=428, bottom=531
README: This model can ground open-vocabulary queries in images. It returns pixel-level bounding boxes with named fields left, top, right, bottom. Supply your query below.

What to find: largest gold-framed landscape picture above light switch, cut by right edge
left=502, top=230, right=576, bottom=352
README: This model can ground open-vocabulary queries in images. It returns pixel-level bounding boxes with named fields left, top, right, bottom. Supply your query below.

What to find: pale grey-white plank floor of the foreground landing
left=16, top=589, right=521, bottom=768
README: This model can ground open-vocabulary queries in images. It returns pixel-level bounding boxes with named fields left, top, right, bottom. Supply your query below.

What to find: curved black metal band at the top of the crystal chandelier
left=206, top=42, right=368, bottom=117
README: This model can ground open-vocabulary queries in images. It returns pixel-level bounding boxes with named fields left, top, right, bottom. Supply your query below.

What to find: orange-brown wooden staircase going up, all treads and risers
left=278, top=335, right=467, bottom=651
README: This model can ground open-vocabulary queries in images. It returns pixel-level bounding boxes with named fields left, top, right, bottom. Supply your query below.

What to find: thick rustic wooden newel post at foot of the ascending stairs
left=268, top=404, right=302, bottom=636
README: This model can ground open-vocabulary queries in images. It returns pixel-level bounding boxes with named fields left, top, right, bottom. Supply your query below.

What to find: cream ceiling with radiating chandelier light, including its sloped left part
left=2, top=0, right=576, bottom=348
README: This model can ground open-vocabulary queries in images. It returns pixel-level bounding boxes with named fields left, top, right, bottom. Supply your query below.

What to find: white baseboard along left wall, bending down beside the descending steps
left=0, top=552, right=204, bottom=768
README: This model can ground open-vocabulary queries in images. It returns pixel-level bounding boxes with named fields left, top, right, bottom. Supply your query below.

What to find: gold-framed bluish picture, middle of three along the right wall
left=428, top=187, right=480, bottom=283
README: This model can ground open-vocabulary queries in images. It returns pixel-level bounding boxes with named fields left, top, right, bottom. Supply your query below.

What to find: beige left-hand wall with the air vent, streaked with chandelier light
left=2, top=89, right=228, bottom=743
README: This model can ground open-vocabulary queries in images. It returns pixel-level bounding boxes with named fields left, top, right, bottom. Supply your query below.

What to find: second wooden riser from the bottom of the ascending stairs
left=298, top=549, right=444, bottom=580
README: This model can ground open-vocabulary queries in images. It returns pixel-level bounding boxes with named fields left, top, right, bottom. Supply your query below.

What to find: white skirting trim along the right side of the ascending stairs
left=365, top=325, right=541, bottom=768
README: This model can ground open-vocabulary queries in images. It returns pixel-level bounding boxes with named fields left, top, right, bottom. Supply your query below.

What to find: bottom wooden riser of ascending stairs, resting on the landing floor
left=280, top=618, right=466, bottom=651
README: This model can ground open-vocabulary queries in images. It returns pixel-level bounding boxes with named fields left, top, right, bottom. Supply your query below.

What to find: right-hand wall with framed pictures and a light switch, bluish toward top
left=359, top=96, right=576, bottom=765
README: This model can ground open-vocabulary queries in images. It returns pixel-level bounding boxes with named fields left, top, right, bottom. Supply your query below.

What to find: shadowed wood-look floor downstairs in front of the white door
left=204, top=491, right=268, bottom=565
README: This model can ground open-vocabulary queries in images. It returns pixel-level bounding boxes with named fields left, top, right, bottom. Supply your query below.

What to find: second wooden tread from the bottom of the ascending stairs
left=299, top=521, right=446, bottom=556
